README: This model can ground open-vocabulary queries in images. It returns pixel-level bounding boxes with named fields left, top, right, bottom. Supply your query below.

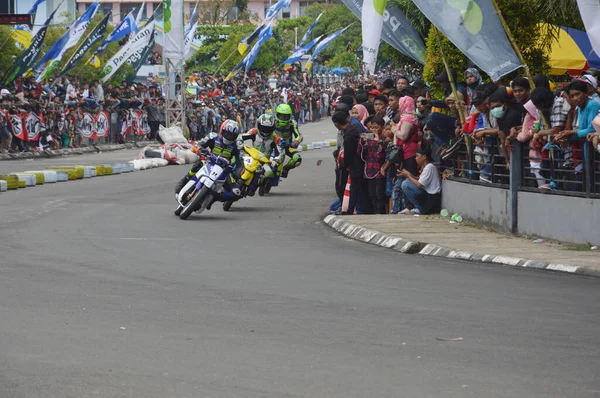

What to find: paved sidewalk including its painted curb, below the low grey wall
left=324, top=215, right=600, bottom=277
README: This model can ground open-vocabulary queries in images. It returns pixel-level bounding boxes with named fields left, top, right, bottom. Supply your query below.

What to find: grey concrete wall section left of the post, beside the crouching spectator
left=442, top=180, right=510, bottom=232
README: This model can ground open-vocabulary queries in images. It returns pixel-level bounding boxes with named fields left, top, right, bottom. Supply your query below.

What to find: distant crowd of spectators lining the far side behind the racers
left=0, top=68, right=360, bottom=153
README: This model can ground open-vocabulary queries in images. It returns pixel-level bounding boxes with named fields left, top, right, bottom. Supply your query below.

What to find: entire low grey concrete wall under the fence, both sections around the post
left=442, top=180, right=600, bottom=244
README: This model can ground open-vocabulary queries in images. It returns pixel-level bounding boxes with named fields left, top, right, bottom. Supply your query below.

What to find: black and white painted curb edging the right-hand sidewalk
left=323, top=214, right=600, bottom=277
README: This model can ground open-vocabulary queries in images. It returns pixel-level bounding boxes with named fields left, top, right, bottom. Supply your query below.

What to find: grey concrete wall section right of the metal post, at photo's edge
left=519, top=192, right=600, bottom=244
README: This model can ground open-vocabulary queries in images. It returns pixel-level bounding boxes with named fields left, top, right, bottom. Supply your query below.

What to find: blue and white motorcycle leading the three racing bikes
left=175, top=154, right=231, bottom=220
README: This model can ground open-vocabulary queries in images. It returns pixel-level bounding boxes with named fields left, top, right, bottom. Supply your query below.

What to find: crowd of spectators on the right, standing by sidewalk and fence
left=331, top=68, right=600, bottom=214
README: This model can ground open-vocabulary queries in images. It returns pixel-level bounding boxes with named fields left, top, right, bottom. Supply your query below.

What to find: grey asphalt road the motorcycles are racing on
left=0, top=122, right=600, bottom=398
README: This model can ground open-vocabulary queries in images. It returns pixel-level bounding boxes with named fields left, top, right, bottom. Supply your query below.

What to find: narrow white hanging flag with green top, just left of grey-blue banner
left=361, top=0, right=386, bottom=74
